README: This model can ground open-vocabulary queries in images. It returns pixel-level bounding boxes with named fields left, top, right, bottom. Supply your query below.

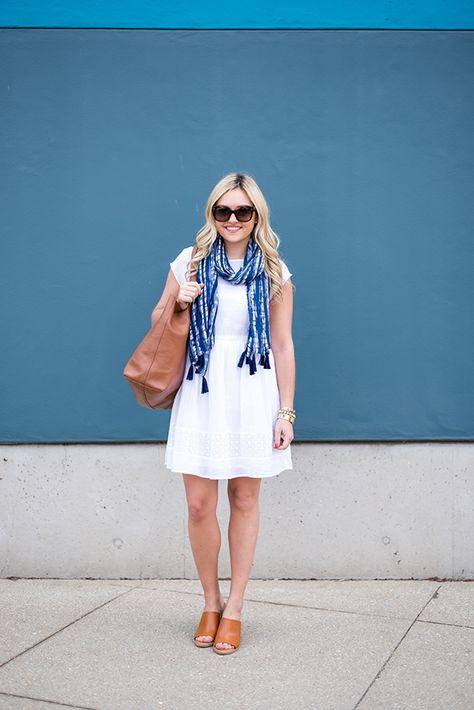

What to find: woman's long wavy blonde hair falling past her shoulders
left=186, top=173, right=292, bottom=300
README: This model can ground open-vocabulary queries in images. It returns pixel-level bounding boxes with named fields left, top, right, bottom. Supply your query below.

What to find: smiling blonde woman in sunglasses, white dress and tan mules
left=152, top=173, right=295, bottom=654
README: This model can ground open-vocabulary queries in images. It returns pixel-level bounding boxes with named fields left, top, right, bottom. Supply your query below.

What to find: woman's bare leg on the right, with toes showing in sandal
left=216, top=476, right=262, bottom=648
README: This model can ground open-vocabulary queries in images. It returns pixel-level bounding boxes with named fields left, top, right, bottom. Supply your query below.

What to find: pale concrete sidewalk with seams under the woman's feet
left=0, top=579, right=474, bottom=710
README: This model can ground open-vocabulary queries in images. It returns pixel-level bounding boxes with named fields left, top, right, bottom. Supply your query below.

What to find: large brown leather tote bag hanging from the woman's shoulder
left=123, top=247, right=196, bottom=409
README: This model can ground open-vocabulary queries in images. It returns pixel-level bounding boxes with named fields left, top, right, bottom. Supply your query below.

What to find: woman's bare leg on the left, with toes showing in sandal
left=183, top=473, right=224, bottom=641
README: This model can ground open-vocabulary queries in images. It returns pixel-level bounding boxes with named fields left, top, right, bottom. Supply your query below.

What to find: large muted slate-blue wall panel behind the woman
left=0, top=29, right=474, bottom=442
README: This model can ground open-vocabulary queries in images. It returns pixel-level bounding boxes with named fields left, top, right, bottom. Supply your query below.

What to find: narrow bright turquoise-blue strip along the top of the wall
left=0, top=0, right=474, bottom=29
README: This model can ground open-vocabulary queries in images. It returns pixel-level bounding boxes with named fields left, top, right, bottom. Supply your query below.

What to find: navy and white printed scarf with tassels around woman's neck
left=186, top=235, right=271, bottom=394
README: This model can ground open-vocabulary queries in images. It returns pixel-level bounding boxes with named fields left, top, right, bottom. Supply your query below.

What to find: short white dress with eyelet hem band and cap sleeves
left=165, top=246, right=293, bottom=479
